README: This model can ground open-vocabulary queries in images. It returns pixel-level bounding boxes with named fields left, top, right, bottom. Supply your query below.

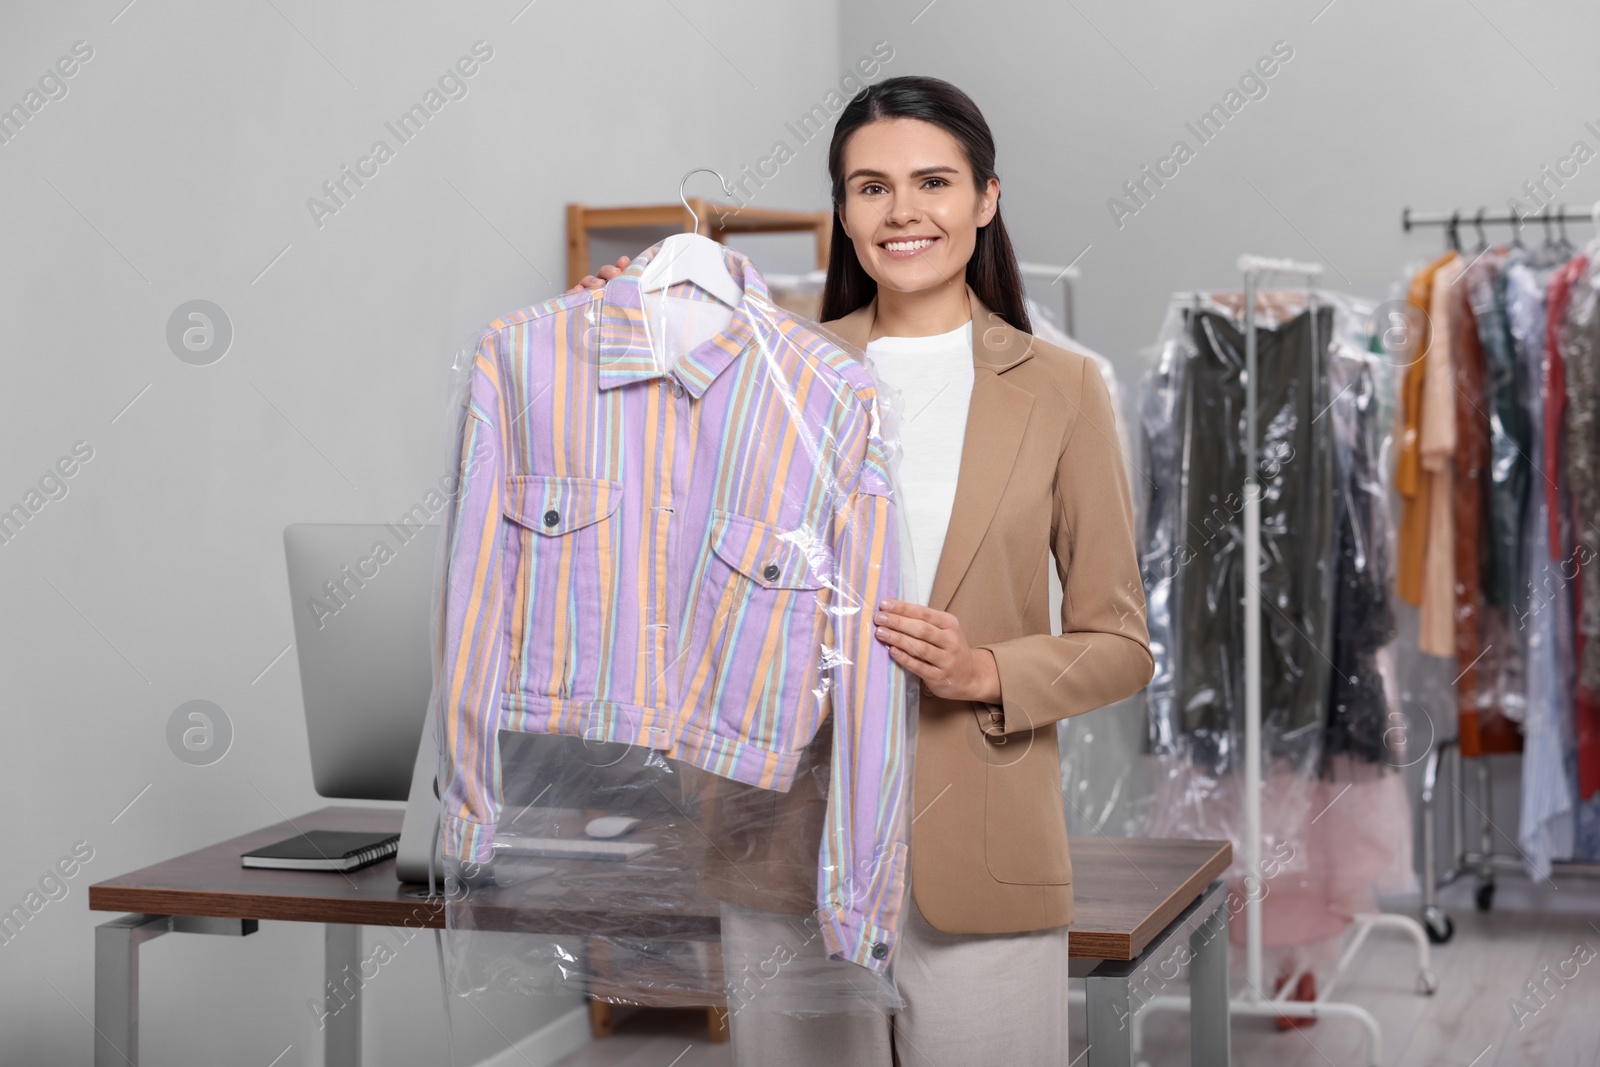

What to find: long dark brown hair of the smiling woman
left=822, top=75, right=1032, bottom=333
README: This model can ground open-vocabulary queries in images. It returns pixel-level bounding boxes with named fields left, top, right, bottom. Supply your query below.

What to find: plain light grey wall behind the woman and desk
left=0, top=0, right=1600, bottom=1067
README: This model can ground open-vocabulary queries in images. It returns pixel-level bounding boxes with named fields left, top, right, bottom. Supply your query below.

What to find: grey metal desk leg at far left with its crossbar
left=94, top=915, right=258, bottom=1067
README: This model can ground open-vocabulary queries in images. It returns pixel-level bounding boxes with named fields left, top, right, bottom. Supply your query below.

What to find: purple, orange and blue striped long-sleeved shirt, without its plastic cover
left=440, top=245, right=909, bottom=971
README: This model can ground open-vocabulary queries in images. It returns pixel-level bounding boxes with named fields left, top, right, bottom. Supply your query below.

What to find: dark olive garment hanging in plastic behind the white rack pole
left=1144, top=307, right=1334, bottom=776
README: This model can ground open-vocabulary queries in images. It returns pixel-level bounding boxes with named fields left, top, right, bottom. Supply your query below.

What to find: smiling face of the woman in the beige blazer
left=840, top=118, right=1000, bottom=293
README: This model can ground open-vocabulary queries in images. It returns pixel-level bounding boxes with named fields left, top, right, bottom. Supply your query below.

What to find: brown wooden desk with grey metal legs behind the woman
left=90, top=806, right=1230, bottom=1067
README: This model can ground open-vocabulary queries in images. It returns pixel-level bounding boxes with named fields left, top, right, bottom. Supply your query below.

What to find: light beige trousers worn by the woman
left=722, top=899, right=1067, bottom=1067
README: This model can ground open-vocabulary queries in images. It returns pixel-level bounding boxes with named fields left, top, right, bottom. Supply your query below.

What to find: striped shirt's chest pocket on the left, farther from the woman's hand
left=502, top=475, right=622, bottom=699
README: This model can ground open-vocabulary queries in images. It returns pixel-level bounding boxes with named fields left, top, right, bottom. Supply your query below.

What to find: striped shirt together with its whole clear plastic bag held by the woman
left=435, top=243, right=917, bottom=1013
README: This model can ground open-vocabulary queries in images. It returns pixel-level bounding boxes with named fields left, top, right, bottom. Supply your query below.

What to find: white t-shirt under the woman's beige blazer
left=867, top=322, right=973, bottom=605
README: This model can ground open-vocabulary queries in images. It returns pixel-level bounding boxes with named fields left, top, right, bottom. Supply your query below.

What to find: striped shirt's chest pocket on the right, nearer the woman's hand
left=685, top=510, right=832, bottom=745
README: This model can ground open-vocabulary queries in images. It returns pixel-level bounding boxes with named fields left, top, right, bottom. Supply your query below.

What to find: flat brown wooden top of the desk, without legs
left=90, top=806, right=1232, bottom=960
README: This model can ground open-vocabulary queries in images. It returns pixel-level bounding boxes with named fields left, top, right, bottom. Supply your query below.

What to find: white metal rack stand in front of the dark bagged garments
left=1133, top=256, right=1438, bottom=1067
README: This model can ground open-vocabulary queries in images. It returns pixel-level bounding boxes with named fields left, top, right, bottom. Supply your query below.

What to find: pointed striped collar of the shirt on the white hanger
left=594, top=242, right=771, bottom=398
